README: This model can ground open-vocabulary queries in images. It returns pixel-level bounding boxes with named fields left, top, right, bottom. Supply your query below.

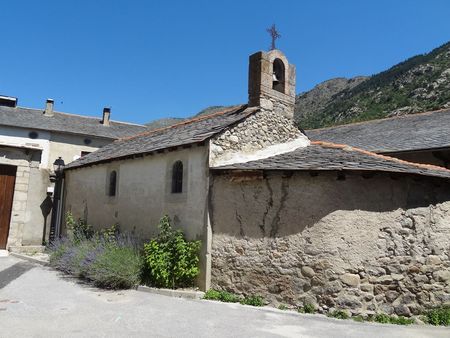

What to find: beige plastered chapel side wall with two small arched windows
left=65, top=147, right=208, bottom=239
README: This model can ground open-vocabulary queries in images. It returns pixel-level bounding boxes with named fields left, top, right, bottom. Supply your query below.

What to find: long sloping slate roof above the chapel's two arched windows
left=66, top=105, right=258, bottom=169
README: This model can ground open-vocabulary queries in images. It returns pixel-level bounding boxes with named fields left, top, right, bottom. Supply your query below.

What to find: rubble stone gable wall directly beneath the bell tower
left=210, top=105, right=308, bottom=165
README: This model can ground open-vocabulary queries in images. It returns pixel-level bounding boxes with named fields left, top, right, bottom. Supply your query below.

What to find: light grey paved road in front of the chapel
left=0, top=257, right=450, bottom=338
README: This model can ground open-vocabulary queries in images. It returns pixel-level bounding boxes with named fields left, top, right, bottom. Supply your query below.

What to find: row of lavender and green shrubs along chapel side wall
left=48, top=214, right=200, bottom=289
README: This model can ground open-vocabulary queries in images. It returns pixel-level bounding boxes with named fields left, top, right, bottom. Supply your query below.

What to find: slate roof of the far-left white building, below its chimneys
left=0, top=106, right=147, bottom=139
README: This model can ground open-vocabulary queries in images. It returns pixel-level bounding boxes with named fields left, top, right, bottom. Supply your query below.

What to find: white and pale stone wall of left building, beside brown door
left=0, top=126, right=112, bottom=246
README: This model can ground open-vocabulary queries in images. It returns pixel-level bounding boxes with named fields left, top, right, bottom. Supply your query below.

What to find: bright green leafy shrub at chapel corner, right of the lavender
left=144, top=216, right=200, bottom=288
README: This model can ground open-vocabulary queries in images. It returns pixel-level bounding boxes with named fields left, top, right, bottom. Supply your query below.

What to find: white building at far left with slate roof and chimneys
left=0, top=96, right=146, bottom=250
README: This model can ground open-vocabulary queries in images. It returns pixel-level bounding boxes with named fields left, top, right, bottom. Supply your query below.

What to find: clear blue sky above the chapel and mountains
left=0, top=0, right=450, bottom=123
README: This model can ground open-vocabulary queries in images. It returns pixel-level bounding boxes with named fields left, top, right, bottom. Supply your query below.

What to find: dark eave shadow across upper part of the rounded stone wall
left=209, top=172, right=450, bottom=238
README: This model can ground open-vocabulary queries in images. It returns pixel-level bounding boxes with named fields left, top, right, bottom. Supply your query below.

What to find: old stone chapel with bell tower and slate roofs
left=62, top=50, right=450, bottom=315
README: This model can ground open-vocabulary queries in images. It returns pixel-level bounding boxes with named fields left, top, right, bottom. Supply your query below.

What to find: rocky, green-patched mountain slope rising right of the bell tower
left=295, top=42, right=450, bottom=129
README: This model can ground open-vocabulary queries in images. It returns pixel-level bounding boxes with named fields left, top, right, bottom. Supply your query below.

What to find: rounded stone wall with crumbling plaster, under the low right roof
left=210, top=173, right=450, bottom=316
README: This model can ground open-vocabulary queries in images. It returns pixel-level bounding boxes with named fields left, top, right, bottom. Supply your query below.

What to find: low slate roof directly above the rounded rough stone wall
left=212, top=141, right=450, bottom=179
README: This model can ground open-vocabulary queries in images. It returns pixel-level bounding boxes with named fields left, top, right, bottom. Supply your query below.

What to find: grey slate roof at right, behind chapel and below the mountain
left=306, top=109, right=450, bottom=153
